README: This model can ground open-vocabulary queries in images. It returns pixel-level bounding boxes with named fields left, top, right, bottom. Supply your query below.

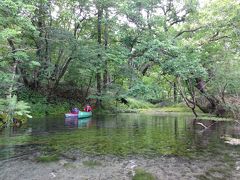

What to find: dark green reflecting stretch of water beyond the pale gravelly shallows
left=0, top=114, right=240, bottom=162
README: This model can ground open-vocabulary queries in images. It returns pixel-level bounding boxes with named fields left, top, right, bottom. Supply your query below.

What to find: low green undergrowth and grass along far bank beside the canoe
left=18, top=89, right=188, bottom=118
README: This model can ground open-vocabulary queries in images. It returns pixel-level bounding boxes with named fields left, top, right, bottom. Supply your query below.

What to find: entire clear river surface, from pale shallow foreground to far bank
left=0, top=113, right=240, bottom=179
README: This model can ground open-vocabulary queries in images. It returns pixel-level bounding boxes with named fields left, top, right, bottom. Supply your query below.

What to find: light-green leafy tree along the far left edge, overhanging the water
left=0, top=0, right=36, bottom=126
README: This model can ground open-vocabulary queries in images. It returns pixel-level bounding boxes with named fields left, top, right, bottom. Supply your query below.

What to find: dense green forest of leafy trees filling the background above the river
left=0, top=0, right=240, bottom=126
